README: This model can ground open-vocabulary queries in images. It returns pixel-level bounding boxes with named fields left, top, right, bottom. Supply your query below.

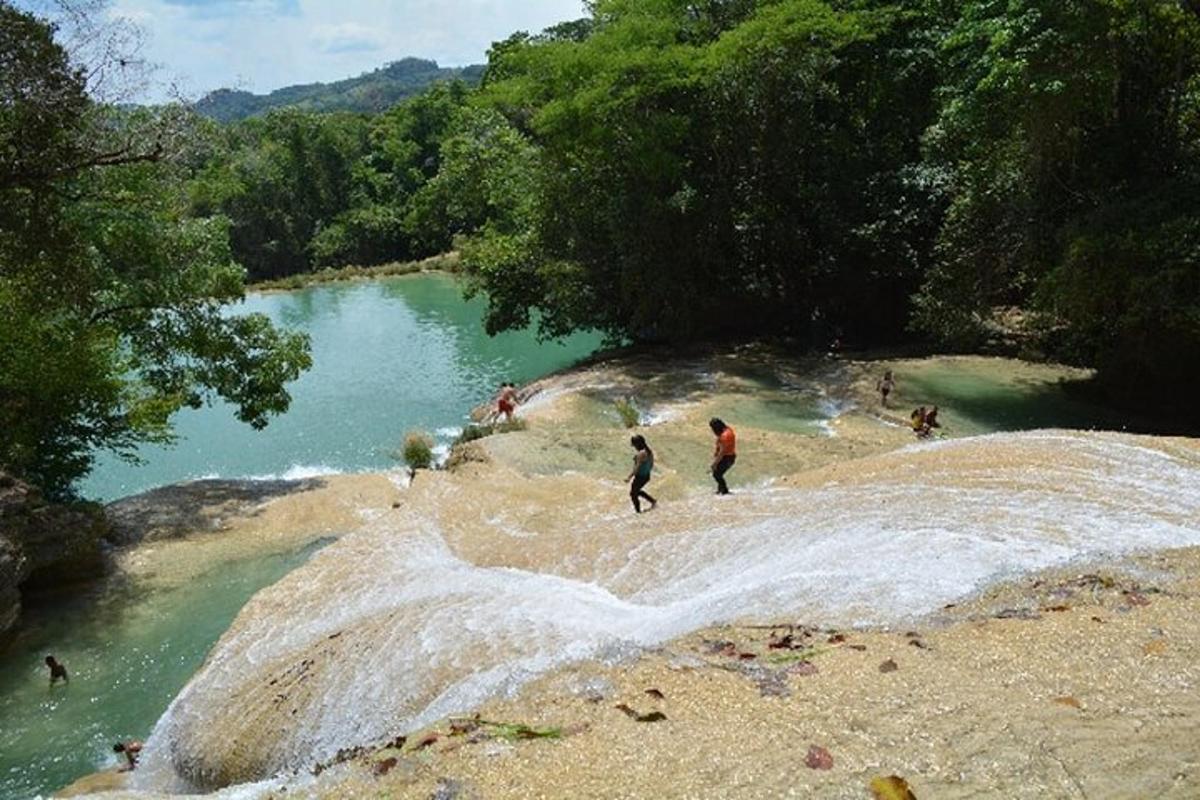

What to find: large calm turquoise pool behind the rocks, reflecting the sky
left=80, top=275, right=600, bottom=500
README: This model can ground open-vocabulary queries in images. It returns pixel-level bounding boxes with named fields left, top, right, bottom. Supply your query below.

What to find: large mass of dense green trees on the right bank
left=433, top=0, right=1200, bottom=407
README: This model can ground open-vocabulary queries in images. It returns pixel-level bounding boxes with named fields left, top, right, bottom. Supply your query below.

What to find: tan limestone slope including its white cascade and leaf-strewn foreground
left=44, top=348, right=1200, bottom=798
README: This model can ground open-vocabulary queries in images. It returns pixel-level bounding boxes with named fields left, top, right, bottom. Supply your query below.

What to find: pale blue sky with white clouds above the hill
left=32, top=0, right=583, bottom=97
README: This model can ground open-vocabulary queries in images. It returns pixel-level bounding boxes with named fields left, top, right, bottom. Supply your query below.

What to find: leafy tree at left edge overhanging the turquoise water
left=0, top=2, right=310, bottom=495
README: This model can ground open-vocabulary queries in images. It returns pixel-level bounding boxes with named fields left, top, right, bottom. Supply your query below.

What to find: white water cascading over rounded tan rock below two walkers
left=138, top=432, right=1200, bottom=790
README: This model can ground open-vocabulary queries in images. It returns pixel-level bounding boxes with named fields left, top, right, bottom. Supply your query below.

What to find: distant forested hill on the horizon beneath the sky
left=196, top=59, right=484, bottom=122
